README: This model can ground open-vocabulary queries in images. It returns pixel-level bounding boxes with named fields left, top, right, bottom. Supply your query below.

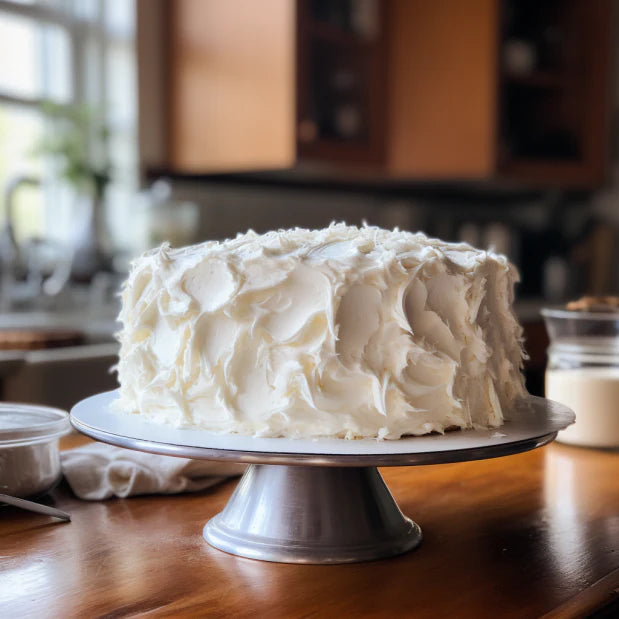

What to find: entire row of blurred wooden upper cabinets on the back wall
left=153, top=0, right=611, bottom=187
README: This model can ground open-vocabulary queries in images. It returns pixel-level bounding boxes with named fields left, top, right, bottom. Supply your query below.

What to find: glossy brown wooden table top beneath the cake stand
left=0, top=444, right=619, bottom=618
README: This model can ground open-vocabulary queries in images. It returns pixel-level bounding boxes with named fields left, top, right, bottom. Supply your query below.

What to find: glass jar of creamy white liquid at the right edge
left=542, top=309, right=619, bottom=447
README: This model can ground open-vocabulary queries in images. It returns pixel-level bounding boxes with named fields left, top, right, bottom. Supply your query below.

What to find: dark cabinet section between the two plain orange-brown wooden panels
left=296, top=0, right=386, bottom=164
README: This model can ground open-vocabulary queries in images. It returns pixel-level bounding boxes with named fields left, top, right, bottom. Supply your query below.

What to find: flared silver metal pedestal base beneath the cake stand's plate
left=204, top=464, right=422, bottom=563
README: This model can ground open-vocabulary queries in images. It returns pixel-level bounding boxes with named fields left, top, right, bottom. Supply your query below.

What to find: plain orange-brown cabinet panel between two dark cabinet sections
left=386, top=0, right=499, bottom=180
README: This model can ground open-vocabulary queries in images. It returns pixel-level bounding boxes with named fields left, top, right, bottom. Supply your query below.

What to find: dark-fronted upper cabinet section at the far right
left=497, top=0, right=611, bottom=185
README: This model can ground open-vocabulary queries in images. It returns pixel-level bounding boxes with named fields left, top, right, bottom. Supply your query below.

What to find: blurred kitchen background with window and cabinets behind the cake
left=0, top=0, right=619, bottom=407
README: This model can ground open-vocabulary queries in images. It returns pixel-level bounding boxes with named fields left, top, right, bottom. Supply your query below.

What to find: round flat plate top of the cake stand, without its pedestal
left=71, top=391, right=574, bottom=466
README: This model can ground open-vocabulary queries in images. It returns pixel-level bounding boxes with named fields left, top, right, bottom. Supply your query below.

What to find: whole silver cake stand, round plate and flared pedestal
left=71, top=391, right=574, bottom=563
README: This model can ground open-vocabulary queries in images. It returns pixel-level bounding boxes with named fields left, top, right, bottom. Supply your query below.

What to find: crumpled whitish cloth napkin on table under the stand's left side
left=60, top=443, right=245, bottom=501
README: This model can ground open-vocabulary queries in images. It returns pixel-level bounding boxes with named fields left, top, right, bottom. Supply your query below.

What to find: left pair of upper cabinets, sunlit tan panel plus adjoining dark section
left=167, top=0, right=385, bottom=173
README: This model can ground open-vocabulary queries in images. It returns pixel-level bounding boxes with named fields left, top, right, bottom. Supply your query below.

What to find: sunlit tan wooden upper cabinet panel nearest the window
left=167, top=0, right=296, bottom=173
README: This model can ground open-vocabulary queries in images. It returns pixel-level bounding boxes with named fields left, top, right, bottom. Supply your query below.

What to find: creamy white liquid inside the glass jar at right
left=546, top=367, right=619, bottom=447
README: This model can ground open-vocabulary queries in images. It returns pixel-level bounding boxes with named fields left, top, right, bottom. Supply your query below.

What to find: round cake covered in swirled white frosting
left=118, top=224, right=525, bottom=439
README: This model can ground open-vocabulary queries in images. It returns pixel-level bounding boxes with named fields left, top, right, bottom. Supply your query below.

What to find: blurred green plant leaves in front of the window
left=35, top=101, right=111, bottom=199
